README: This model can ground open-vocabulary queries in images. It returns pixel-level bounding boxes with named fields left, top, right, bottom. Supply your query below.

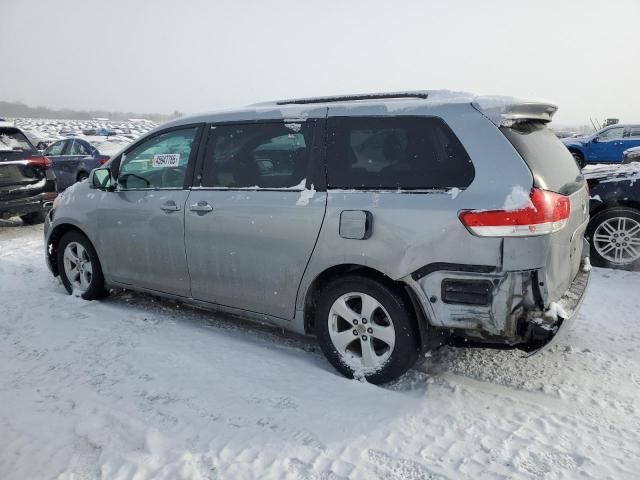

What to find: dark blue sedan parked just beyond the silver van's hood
left=44, top=138, right=109, bottom=191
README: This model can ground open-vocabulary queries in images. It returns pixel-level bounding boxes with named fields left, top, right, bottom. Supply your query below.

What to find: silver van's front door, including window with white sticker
left=97, top=125, right=202, bottom=297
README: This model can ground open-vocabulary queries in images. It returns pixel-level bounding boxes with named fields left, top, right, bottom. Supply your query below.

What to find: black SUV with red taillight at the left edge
left=0, top=126, right=56, bottom=224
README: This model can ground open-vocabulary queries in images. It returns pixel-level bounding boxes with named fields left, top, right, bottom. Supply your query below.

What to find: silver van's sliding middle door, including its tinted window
left=185, top=120, right=326, bottom=319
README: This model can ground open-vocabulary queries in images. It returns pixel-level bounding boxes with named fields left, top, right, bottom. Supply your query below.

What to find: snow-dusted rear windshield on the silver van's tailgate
left=500, top=122, right=584, bottom=195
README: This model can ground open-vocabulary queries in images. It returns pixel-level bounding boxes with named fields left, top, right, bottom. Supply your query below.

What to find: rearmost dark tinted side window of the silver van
left=327, top=117, right=475, bottom=190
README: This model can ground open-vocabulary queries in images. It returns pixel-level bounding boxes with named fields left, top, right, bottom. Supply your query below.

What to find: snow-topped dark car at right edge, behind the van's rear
left=583, top=163, right=640, bottom=269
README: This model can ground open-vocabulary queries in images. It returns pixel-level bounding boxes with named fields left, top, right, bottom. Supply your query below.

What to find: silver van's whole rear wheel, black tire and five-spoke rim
left=315, top=275, right=420, bottom=384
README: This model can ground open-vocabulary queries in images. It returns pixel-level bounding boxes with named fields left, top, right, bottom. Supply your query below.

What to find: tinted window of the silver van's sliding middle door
left=202, top=122, right=314, bottom=190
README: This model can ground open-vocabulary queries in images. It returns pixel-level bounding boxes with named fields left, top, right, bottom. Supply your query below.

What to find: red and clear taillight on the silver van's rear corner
left=459, top=188, right=571, bottom=237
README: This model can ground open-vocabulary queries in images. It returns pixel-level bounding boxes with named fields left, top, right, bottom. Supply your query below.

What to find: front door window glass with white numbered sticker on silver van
left=118, top=127, right=200, bottom=190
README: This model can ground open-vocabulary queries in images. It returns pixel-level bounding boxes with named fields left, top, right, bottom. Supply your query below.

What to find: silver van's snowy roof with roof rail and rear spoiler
left=163, top=90, right=557, bottom=127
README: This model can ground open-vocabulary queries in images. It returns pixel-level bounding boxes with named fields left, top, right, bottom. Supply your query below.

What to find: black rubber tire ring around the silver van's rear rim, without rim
left=315, top=275, right=420, bottom=384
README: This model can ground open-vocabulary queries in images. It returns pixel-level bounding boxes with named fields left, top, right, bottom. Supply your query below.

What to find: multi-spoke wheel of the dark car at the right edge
left=587, top=207, right=640, bottom=270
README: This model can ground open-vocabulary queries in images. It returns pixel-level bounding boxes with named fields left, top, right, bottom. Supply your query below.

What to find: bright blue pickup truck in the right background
left=561, top=124, right=640, bottom=167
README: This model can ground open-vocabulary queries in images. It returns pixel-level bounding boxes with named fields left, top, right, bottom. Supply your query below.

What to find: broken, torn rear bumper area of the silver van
left=403, top=241, right=591, bottom=352
